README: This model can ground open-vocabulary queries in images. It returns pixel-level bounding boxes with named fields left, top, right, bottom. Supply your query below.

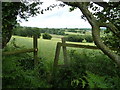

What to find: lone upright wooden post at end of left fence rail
left=33, top=36, right=38, bottom=66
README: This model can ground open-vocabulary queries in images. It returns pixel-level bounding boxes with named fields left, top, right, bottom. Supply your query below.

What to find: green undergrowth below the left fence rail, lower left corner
left=2, top=44, right=51, bottom=89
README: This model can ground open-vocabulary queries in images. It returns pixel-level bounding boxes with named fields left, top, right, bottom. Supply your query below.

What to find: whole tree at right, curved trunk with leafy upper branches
left=60, top=0, right=120, bottom=66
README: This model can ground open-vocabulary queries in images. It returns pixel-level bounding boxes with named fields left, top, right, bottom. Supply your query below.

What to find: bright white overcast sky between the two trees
left=20, top=0, right=91, bottom=28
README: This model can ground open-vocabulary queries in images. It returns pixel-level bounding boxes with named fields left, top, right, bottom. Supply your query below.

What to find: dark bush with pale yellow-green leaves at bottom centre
left=53, top=59, right=88, bottom=89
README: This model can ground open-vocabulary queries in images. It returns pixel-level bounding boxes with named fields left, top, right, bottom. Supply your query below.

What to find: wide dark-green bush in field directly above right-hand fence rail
left=67, top=35, right=84, bottom=42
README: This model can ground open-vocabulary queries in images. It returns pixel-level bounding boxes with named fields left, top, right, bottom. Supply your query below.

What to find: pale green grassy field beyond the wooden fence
left=8, top=35, right=94, bottom=64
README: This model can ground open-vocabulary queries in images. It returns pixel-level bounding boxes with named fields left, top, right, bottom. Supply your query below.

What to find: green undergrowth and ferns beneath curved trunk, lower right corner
left=69, top=50, right=120, bottom=90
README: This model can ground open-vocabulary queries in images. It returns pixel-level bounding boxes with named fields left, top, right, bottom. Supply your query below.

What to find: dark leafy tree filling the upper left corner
left=2, top=2, right=42, bottom=48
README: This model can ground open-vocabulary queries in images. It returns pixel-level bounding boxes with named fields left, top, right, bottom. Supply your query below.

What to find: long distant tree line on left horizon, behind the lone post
left=13, top=26, right=65, bottom=38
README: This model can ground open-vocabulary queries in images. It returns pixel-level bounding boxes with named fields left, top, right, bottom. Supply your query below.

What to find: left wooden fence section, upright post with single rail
left=2, top=36, right=38, bottom=66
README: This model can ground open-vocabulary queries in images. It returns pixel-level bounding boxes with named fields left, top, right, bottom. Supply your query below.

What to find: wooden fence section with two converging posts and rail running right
left=53, top=38, right=117, bottom=68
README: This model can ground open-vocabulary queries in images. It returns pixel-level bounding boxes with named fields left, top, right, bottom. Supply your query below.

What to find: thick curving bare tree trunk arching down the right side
left=62, top=2, right=120, bottom=67
